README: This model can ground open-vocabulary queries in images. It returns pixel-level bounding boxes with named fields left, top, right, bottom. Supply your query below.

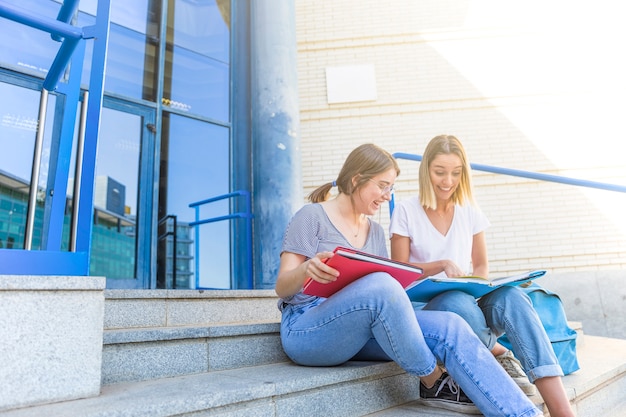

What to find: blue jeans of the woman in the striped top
left=281, top=273, right=541, bottom=417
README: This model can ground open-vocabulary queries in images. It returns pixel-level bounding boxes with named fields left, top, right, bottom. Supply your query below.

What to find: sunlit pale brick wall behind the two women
left=296, top=0, right=626, bottom=275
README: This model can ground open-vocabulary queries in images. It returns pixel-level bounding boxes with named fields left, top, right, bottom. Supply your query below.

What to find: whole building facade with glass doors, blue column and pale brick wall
left=0, top=0, right=626, bottom=288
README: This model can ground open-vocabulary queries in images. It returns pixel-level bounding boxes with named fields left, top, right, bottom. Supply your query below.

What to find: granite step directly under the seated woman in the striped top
left=0, top=362, right=418, bottom=417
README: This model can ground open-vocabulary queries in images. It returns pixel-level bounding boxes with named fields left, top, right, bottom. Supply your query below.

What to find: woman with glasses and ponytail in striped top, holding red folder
left=275, top=144, right=542, bottom=417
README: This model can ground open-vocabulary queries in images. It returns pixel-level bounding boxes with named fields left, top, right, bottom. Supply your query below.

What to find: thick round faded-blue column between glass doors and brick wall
left=250, top=0, right=302, bottom=289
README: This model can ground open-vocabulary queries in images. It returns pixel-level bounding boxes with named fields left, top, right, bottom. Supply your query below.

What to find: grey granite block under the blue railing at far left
left=0, top=275, right=105, bottom=411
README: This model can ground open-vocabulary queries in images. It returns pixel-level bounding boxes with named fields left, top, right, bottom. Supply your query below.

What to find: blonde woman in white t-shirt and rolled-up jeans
left=389, top=135, right=573, bottom=417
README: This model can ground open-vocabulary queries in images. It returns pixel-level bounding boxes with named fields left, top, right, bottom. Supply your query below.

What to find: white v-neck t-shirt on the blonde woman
left=389, top=197, right=490, bottom=276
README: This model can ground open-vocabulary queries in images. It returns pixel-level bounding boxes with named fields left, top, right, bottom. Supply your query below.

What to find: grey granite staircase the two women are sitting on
left=8, top=290, right=626, bottom=417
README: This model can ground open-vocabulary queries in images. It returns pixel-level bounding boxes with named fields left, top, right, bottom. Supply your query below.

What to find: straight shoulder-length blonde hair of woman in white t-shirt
left=419, top=135, right=474, bottom=210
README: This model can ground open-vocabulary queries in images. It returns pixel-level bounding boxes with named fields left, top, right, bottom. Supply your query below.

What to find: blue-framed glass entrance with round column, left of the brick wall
left=0, top=0, right=301, bottom=289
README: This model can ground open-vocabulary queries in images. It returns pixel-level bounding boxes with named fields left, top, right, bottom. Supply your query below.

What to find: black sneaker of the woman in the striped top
left=420, top=372, right=482, bottom=414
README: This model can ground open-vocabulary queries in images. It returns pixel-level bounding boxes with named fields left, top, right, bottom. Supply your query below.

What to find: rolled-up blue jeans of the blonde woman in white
left=424, top=286, right=563, bottom=383
